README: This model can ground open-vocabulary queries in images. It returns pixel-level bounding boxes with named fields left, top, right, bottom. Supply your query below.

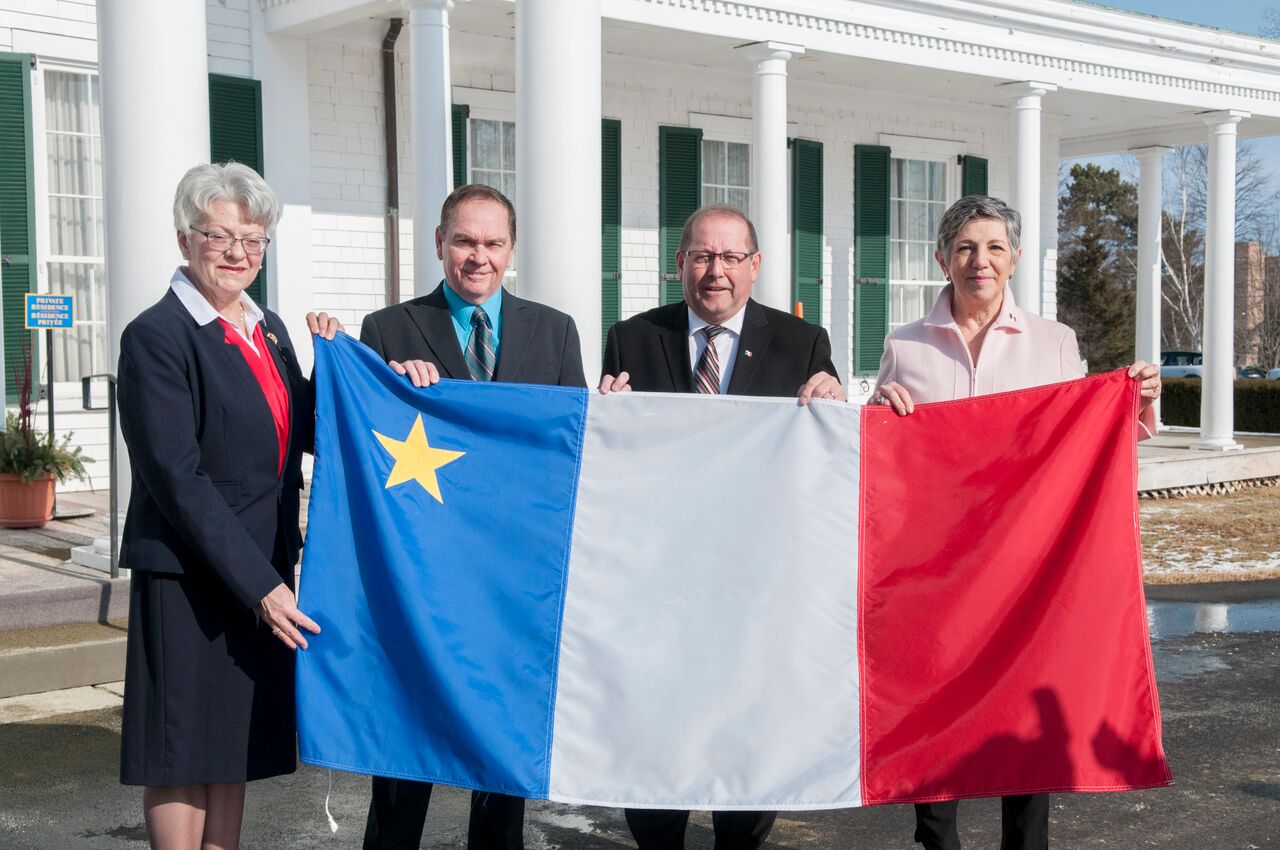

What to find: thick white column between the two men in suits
left=516, top=0, right=602, bottom=384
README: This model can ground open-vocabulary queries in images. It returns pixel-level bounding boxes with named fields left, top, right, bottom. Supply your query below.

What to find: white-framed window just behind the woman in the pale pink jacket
left=888, top=157, right=955, bottom=330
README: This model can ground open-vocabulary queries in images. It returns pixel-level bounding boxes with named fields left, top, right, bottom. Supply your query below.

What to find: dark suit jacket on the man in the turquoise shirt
left=360, top=283, right=586, bottom=387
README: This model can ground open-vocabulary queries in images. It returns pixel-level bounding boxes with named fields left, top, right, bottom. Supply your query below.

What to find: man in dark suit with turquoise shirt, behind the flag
left=360, top=184, right=586, bottom=850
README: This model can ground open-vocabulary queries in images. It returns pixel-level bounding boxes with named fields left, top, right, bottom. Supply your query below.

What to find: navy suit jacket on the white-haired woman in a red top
left=118, top=291, right=315, bottom=608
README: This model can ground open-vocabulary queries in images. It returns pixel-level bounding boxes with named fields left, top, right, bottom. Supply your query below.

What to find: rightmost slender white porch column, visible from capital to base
left=1192, top=109, right=1249, bottom=451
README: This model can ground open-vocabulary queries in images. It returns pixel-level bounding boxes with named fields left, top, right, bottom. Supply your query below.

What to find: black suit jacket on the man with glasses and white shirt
left=603, top=300, right=840, bottom=397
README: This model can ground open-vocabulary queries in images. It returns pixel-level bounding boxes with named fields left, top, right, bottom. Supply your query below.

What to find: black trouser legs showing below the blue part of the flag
left=364, top=776, right=525, bottom=850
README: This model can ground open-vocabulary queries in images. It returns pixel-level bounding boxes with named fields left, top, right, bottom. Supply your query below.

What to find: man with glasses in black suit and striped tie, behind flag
left=600, top=204, right=845, bottom=850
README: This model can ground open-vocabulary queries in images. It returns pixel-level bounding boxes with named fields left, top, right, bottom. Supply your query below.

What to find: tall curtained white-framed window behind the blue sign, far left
left=44, top=68, right=111, bottom=381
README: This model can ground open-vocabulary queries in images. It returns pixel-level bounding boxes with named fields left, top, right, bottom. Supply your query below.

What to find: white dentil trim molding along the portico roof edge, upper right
left=603, top=0, right=1280, bottom=116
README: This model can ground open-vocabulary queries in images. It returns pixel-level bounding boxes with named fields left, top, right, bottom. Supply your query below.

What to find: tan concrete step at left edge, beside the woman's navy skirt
left=0, top=621, right=125, bottom=699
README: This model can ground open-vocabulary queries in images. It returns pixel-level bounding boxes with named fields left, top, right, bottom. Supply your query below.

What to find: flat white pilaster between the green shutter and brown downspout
left=248, top=3, right=313, bottom=375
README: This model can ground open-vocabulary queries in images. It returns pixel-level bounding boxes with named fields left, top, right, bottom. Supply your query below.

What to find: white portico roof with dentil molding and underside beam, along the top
left=261, top=0, right=1280, bottom=156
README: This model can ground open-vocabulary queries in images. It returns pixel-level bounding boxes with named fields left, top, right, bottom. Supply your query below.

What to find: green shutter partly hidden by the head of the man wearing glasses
left=658, top=127, right=703, bottom=303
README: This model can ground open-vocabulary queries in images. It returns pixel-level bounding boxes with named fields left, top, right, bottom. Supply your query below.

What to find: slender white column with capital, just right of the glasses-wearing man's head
left=739, top=41, right=804, bottom=312
